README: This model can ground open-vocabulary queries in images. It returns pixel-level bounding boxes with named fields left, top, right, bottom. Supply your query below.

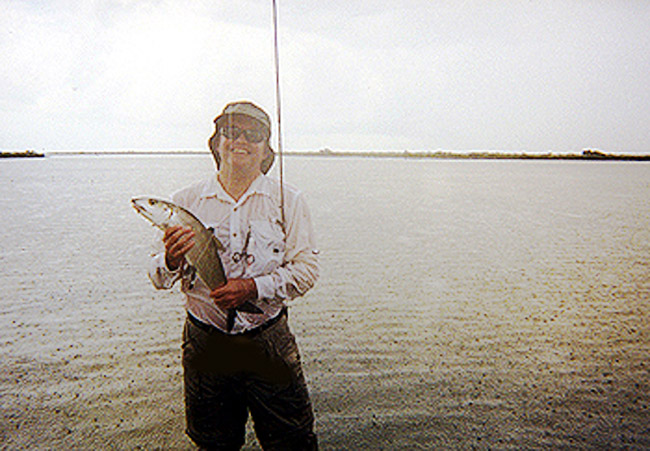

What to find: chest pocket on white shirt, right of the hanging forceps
left=249, top=219, right=285, bottom=274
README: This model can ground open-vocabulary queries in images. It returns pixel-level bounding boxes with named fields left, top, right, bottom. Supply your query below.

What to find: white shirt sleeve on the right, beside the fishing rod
left=253, top=194, right=319, bottom=300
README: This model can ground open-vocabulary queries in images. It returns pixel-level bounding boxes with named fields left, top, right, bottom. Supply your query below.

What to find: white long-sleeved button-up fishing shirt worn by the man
left=149, top=174, right=319, bottom=333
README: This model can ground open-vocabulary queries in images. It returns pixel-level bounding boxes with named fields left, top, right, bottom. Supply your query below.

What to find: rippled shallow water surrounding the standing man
left=0, top=155, right=650, bottom=449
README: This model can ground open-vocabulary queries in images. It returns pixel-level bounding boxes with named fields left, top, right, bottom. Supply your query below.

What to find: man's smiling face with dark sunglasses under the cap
left=217, top=115, right=268, bottom=172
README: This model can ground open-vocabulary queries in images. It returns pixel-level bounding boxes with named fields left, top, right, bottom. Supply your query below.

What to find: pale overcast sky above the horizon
left=0, top=0, right=650, bottom=154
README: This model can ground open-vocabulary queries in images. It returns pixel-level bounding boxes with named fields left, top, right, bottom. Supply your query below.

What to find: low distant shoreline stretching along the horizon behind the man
left=41, top=149, right=650, bottom=161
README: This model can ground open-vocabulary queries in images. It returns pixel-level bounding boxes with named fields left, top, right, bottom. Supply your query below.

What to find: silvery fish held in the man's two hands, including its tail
left=131, top=197, right=263, bottom=331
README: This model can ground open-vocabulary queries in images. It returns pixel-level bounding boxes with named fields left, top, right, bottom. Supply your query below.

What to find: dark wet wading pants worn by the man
left=183, top=311, right=318, bottom=450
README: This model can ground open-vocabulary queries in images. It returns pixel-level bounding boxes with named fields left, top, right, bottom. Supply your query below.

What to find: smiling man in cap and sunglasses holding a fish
left=149, top=102, right=318, bottom=450
